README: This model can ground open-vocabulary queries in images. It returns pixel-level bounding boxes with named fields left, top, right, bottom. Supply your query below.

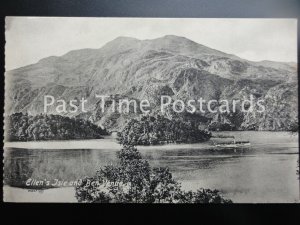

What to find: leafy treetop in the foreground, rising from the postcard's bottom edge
left=75, top=146, right=231, bottom=203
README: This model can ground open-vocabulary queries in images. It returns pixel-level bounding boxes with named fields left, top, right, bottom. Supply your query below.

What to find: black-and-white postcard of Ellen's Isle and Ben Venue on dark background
left=3, top=17, right=299, bottom=203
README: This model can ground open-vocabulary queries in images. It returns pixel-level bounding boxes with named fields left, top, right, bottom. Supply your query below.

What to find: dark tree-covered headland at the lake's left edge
left=7, top=113, right=107, bottom=141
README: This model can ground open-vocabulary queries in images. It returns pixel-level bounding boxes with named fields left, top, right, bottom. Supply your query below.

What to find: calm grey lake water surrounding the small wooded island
left=4, top=131, right=299, bottom=203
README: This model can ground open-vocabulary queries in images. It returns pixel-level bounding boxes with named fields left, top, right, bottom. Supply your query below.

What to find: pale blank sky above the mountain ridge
left=5, top=17, right=297, bottom=70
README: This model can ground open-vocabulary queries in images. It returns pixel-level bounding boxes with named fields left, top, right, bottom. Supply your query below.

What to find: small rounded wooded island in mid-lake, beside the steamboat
left=118, top=115, right=211, bottom=145
